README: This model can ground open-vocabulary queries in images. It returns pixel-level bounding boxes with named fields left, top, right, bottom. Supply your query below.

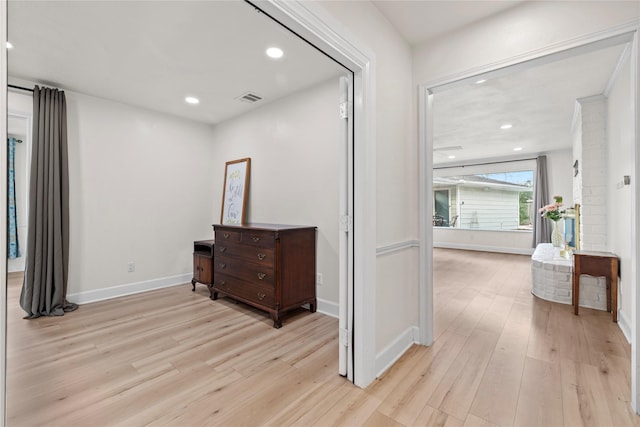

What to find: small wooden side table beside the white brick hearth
left=572, top=251, right=618, bottom=323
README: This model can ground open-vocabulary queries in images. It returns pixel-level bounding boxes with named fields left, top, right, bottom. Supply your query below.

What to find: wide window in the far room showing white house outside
left=433, top=166, right=535, bottom=231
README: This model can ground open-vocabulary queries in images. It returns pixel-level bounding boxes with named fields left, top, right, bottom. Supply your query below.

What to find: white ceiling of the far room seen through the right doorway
left=433, top=45, right=624, bottom=164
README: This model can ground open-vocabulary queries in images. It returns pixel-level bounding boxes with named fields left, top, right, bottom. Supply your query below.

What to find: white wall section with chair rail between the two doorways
left=317, top=1, right=418, bottom=362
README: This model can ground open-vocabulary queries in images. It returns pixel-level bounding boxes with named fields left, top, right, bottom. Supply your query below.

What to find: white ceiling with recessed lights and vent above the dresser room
left=8, top=1, right=345, bottom=124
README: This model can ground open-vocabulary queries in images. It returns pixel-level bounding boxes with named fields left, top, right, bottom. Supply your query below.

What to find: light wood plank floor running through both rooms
left=7, top=250, right=640, bottom=427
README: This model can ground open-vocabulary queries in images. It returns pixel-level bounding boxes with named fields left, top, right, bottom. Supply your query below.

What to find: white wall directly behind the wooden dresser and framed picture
left=209, top=78, right=341, bottom=308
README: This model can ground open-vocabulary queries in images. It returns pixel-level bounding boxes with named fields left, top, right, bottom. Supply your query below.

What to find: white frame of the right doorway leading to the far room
left=418, top=22, right=640, bottom=413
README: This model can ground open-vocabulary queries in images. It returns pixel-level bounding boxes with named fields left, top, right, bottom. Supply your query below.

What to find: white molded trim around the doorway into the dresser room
left=260, top=0, right=376, bottom=387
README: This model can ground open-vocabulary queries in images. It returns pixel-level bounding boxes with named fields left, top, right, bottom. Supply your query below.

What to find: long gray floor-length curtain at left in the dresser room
left=20, top=86, right=78, bottom=318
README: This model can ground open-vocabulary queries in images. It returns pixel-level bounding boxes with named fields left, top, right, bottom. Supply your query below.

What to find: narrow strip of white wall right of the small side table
left=606, top=51, right=637, bottom=338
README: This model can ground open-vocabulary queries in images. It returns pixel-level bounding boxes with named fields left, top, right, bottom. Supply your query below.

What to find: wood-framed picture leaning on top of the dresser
left=220, top=158, right=251, bottom=224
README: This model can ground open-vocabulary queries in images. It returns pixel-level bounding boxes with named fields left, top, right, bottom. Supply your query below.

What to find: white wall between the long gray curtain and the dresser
left=65, top=91, right=215, bottom=302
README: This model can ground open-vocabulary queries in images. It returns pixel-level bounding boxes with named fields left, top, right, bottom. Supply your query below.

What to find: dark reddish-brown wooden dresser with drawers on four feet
left=211, top=224, right=316, bottom=328
